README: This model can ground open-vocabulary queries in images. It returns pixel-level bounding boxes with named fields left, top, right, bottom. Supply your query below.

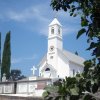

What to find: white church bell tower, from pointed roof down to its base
left=47, top=18, right=63, bottom=77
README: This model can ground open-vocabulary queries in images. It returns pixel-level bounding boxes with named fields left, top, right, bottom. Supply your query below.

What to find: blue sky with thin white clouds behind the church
left=0, top=0, right=91, bottom=76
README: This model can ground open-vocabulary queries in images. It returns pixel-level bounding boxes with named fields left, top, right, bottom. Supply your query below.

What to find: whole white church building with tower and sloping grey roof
left=39, top=18, right=85, bottom=78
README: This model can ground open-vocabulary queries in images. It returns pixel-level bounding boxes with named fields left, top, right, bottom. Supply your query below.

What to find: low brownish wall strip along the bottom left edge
left=0, top=95, right=43, bottom=100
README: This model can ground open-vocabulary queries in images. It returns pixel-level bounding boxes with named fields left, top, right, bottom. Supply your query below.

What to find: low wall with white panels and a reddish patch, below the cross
left=0, top=78, right=51, bottom=97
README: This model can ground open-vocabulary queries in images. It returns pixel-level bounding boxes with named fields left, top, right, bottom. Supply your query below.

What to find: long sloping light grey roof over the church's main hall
left=62, top=50, right=85, bottom=66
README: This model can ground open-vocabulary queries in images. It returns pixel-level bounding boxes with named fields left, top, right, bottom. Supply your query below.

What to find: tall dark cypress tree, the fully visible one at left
left=1, top=31, right=11, bottom=79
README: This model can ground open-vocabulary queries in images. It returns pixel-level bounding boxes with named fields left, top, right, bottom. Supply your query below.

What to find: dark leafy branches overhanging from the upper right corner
left=51, top=0, right=100, bottom=63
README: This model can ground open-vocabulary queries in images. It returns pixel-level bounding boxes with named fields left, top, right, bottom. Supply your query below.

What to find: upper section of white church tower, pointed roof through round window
left=48, top=18, right=63, bottom=53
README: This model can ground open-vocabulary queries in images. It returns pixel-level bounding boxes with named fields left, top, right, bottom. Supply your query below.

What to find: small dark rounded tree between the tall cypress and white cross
left=9, top=69, right=26, bottom=81
